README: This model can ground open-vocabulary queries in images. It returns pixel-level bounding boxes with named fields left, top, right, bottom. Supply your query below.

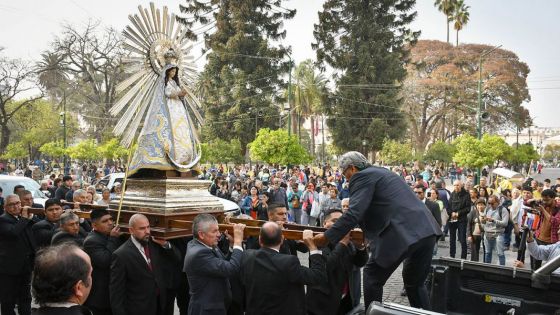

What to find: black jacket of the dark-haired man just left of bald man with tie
left=84, top=231, right=122, bottom=310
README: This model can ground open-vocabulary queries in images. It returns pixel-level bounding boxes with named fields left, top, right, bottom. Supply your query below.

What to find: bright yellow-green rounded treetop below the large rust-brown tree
left=453, top=134, right=511, bottom=168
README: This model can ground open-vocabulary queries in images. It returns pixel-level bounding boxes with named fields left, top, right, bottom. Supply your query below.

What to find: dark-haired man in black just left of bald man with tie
left=84, top=209, right=122, bottom=315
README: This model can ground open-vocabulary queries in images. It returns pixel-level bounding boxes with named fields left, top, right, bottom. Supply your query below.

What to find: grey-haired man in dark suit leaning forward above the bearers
left=315, top=151, right=442, bottom=309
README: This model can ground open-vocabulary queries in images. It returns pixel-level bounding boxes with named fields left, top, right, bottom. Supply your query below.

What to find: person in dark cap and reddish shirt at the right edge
left=528, top=190, right=558, bottom=270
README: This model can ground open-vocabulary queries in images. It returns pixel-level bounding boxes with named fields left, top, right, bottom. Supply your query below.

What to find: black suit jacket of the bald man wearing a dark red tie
left=109, top=239, right=179, bottom=315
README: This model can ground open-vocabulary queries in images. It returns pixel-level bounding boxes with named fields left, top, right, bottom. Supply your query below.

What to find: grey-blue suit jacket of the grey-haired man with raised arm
left=183, top=239, right=243, bottom=315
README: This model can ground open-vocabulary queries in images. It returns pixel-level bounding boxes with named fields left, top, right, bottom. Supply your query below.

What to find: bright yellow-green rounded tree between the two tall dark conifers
left=248, top=128, right=313, bottom=165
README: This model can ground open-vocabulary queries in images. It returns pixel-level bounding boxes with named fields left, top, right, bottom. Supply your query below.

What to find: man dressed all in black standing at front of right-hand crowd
left=447, top=180, right=471, bottom=259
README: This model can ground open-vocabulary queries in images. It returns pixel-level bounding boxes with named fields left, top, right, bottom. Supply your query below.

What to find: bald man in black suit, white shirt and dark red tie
left=109, top=213, right=179, bottom=315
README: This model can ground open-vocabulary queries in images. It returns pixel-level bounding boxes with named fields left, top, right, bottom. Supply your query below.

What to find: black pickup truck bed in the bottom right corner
left=366, top=256, right=560, bottom=315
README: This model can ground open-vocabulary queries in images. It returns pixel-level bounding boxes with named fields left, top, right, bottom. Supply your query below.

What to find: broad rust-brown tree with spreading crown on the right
left=402, top=40, right=531, bottom=152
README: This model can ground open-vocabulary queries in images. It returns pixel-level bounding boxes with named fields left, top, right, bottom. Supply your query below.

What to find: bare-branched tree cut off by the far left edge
left=0, top=56, right=43, bottom=153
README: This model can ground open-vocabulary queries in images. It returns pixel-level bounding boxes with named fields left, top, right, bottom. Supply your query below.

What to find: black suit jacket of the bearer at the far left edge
left=0, top=212, right=36, bottom=276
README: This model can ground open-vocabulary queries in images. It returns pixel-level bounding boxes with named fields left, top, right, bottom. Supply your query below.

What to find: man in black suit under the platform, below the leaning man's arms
left=306, top=210, right=368, bottom=315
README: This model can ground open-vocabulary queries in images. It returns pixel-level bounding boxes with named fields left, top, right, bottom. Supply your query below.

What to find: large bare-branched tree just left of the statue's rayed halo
left=39, top=21, right=125, bottom=141
